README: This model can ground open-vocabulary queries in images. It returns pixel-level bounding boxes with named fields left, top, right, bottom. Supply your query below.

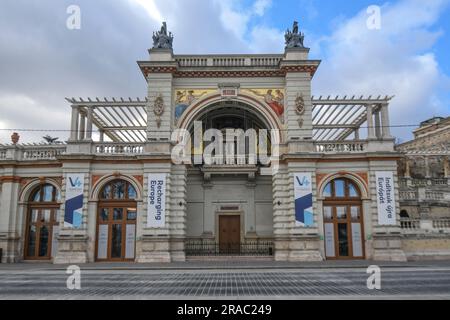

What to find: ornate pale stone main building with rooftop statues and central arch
left=0, top=24, right=414, bottom=263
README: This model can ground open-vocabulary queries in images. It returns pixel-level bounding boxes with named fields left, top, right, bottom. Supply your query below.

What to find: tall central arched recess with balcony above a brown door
left=180, top=100, right=278, bottom=257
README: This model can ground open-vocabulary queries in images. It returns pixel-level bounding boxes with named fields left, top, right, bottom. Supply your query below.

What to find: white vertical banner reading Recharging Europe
left=147, top=173, right=167, bottom=228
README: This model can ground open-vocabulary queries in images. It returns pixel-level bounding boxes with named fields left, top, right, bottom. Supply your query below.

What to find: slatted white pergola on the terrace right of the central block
left=312, top=96, right=393, bottom=141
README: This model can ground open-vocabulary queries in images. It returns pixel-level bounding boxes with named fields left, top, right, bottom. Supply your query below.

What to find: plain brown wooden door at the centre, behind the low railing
left=219, top=215, right=241, bottom=254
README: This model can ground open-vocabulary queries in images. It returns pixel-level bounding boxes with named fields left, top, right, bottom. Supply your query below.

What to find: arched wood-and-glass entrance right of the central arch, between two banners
left=323, top=178, right=365, bottom=259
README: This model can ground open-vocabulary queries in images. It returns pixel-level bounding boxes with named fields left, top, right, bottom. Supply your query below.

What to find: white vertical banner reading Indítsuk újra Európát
left=376, top=171, right=397, bottom=226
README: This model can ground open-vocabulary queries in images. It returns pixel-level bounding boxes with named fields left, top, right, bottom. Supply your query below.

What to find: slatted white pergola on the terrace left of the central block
left=66, top=98, right=148, bottom=143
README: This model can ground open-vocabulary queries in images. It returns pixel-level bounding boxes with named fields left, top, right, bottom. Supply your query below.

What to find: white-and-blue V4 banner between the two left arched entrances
left=64, top=174, right=84, bottom=229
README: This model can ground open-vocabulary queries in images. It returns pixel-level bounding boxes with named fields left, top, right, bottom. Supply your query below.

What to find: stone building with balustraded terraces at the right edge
left=396, top=117, right=450, bottom=259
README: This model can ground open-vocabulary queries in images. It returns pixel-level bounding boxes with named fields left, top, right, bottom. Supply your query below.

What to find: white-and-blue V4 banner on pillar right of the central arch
left=294, top=173, right=314, bottom=227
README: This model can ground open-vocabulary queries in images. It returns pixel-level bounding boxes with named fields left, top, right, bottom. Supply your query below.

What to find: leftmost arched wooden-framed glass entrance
left=24, top=184, right=60, bottom=260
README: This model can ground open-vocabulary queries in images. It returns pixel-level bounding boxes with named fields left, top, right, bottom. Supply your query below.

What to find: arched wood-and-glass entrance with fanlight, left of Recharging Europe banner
left=95, top=179, right=137, bottom=261
